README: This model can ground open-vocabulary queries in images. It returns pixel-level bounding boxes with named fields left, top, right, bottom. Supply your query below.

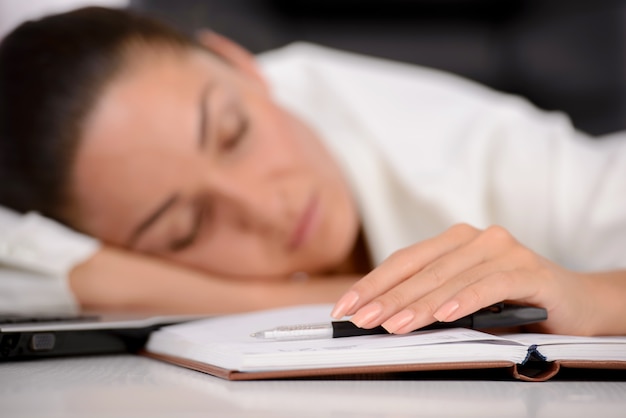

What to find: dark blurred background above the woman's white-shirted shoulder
left=131, top=0, right=626, bottom=135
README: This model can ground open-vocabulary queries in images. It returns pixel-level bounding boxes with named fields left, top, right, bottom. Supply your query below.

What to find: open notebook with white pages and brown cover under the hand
left=144, top=305, right=626, bottom=380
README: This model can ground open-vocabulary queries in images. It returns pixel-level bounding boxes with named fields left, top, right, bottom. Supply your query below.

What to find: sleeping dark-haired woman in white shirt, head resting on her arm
left=0, top=8, right=626, bottom=335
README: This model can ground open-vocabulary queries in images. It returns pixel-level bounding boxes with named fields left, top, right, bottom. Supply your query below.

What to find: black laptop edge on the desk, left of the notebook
left=0, top=313, right=201, bottom=362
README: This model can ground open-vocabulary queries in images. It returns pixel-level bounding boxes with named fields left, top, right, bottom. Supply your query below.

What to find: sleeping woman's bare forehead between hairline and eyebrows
left=70, top=50, right=222, bottom=241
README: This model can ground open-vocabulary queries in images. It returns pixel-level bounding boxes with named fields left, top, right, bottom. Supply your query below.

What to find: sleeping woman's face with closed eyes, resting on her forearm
left=71, top=45, right=358, bottom=279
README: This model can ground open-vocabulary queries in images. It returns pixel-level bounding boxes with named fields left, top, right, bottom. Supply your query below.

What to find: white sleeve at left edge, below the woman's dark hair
left=0, top=207, right=100, bottom=313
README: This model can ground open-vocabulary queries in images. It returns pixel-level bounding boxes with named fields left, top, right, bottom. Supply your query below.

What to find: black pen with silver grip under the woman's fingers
left=251, top=302, right=548, bottom=341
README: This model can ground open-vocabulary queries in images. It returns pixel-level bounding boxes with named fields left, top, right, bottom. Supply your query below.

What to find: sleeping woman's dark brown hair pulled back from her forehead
left=0, top=7, right=197, bottom=222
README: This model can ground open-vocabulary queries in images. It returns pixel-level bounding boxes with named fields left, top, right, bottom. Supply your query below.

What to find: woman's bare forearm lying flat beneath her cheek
left=70, top=247, right=356, bottom=314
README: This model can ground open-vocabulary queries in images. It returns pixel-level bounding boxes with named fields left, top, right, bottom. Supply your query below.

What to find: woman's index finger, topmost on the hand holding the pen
left=331, top=224, right=479, bottom=318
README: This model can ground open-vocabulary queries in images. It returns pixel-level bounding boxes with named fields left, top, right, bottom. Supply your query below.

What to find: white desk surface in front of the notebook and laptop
left=0, top=354, right=626, bottom=418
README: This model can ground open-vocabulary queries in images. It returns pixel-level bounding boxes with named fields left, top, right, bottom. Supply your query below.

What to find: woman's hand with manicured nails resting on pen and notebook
left=332, top=224, right=608, bottom=335
